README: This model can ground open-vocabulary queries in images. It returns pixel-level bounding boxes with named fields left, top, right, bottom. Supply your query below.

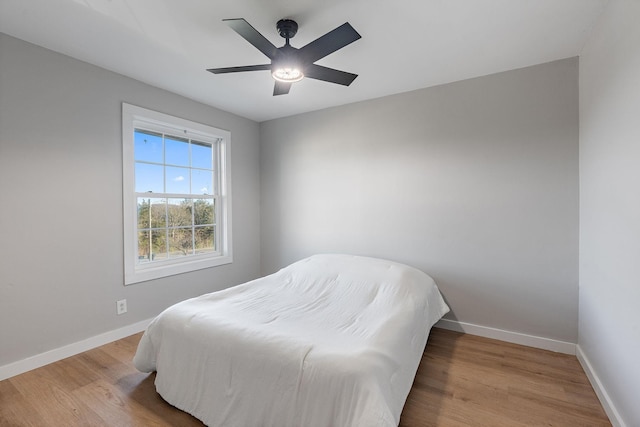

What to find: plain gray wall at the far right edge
left=578, top=0, right=640, bottom=427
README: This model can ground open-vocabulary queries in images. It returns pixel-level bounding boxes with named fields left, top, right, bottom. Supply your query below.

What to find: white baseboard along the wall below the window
left=0, top=319, right=152, bottom=381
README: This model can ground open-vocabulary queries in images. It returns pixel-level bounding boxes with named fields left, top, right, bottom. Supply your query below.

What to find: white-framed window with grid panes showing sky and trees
left=122, top=104, right=232, bottom=285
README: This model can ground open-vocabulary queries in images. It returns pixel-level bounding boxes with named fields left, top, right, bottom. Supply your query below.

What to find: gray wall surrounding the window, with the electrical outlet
left=0, top=35, right=260, bottom=366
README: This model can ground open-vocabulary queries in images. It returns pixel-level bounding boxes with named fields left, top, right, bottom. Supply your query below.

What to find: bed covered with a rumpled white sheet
left=133, top=255, right=449, bottom=427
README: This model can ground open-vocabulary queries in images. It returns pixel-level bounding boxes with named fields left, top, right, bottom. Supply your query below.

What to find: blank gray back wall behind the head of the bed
left=260, top=58, right=578, bottom=343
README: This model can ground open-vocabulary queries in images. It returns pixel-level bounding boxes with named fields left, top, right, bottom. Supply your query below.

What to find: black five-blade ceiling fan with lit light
left=207, top=18, right=361, bottom=96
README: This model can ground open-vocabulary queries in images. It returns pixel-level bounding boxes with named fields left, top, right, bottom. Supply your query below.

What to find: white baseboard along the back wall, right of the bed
left=434, top=319, right=576, bottom=355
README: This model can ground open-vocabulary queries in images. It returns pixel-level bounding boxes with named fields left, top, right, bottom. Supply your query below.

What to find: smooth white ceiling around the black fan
left=0, top=0, right=608, bottom=121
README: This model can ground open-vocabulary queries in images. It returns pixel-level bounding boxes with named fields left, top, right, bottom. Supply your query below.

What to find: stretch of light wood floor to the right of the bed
left=400, top=329, right=611, bottom=427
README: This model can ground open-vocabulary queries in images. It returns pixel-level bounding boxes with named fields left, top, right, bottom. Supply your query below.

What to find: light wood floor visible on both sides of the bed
left=0, top=328, right=611, bottom=427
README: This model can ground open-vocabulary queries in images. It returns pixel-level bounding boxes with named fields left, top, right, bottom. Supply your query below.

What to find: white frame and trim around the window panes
left=122, top=103, right=233, bottom=285
